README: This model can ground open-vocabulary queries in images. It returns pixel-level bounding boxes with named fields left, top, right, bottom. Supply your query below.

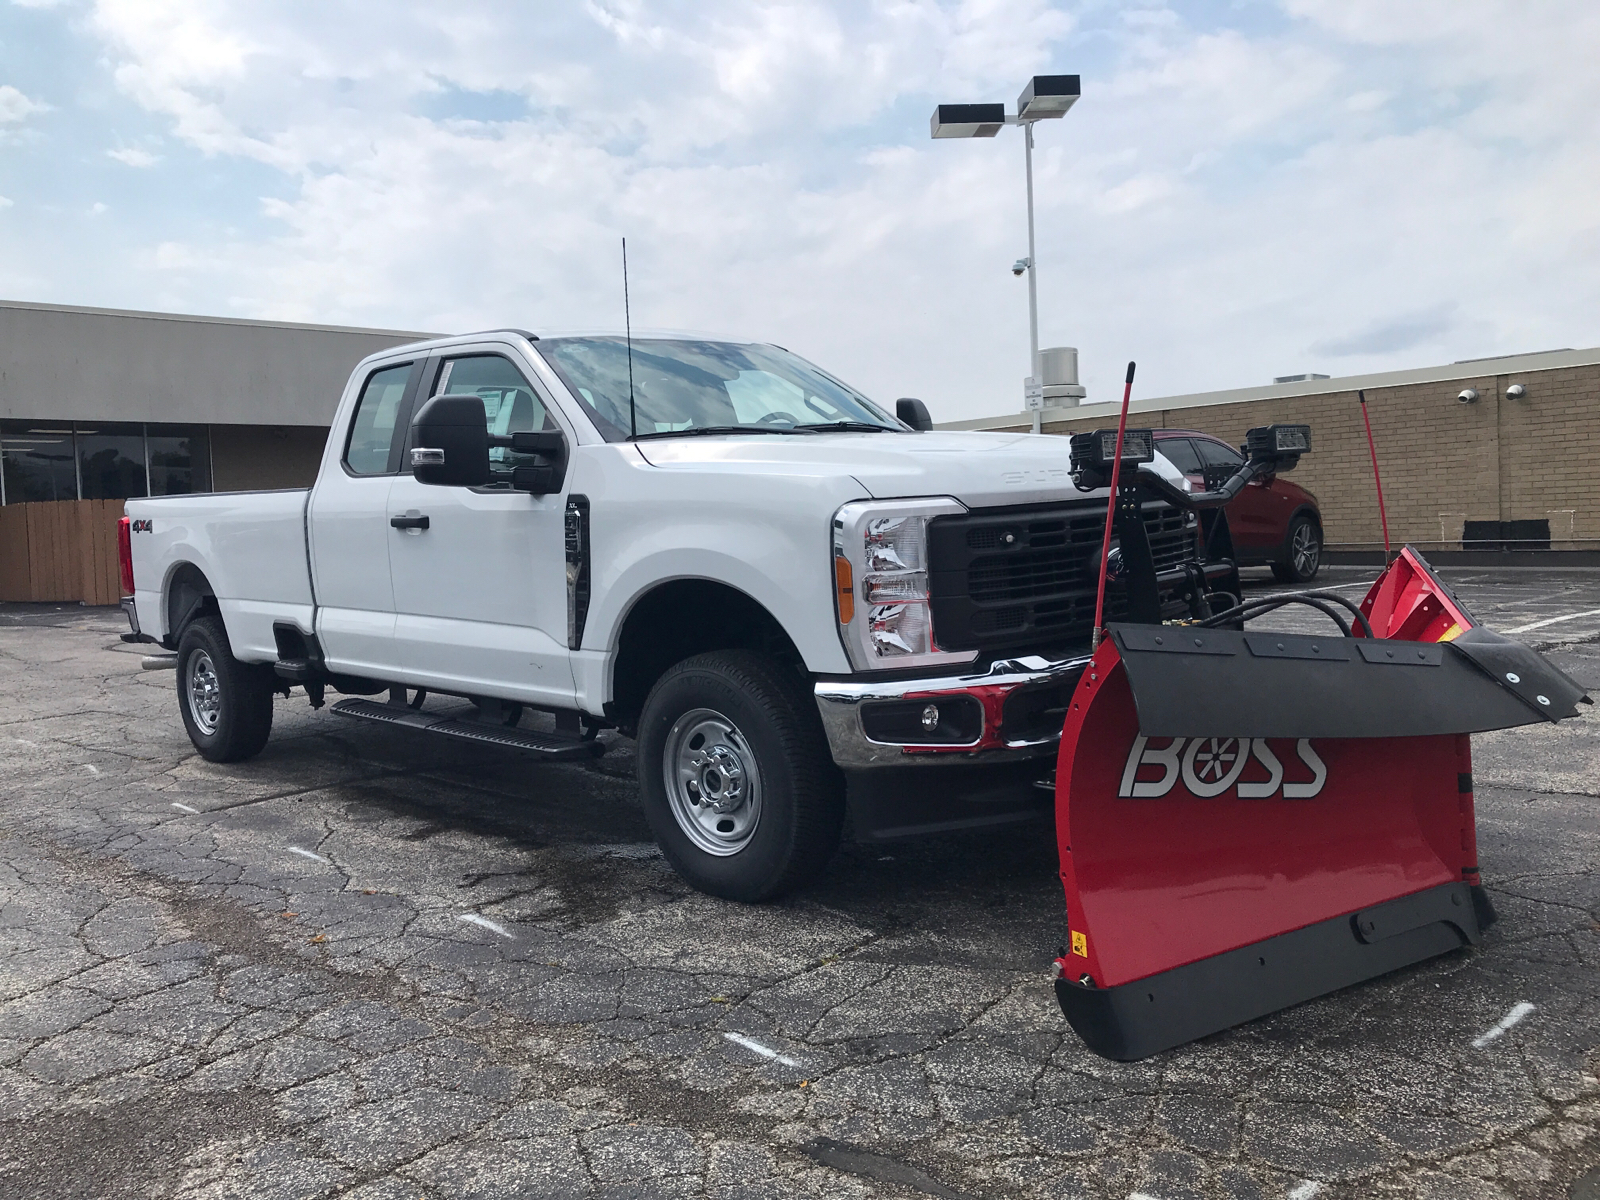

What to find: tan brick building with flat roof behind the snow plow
left=941, top=349, right=1600, bottom=550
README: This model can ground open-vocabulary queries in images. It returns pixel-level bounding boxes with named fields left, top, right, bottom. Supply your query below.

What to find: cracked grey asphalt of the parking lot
left=0, top=570, right=1600, bottom=1200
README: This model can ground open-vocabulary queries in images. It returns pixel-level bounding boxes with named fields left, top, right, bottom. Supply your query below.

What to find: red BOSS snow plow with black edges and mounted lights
left=1056, top=426, right=1587, bottom=1061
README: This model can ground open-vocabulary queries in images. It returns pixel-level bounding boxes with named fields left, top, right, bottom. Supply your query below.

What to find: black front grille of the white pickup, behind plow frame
left=928, top=501, right=1195, bottom=662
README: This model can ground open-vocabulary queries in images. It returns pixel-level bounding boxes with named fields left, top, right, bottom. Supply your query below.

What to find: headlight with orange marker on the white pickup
left=834, top=499, right=978, bottom=670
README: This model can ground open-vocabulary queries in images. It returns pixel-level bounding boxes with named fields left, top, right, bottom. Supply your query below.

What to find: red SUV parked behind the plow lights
left=1155, top=429, right=1322, bottom=584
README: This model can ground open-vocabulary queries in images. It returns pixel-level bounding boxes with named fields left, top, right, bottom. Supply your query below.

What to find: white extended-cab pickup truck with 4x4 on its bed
left=123, top=330, right=1237, bottom=899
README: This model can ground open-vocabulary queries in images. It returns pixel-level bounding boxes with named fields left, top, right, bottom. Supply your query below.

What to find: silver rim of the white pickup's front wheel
left=661, top=709, right=762, bottom=858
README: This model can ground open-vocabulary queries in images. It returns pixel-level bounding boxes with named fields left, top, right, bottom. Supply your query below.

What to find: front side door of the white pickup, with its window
left=389, top=352, right=576, bottom=707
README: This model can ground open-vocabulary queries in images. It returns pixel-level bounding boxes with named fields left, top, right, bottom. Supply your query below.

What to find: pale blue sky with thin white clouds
left=0, top=0, right=1600, bottom=421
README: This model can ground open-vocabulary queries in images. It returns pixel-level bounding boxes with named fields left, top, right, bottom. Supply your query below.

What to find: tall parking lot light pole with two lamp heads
left=930, top=75, right=1085, bottom=434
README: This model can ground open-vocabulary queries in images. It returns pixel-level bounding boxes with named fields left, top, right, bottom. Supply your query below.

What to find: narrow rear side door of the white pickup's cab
left=307, top=360, right=422, bottom=678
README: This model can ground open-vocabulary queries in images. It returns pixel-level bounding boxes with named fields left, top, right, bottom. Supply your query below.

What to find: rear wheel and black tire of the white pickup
left=178, top=616, right=275, bottom=763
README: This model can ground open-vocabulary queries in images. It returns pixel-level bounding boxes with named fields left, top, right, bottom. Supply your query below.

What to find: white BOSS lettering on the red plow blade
left=1117, top=733, right=1328, bottom=800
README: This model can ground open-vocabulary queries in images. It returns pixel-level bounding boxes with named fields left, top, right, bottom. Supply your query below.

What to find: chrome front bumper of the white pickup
left=816, top=654, right=1090, bottom=770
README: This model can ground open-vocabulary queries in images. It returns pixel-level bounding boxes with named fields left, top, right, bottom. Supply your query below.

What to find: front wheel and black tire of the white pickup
left=638, top=650, right=845, bottom=901
